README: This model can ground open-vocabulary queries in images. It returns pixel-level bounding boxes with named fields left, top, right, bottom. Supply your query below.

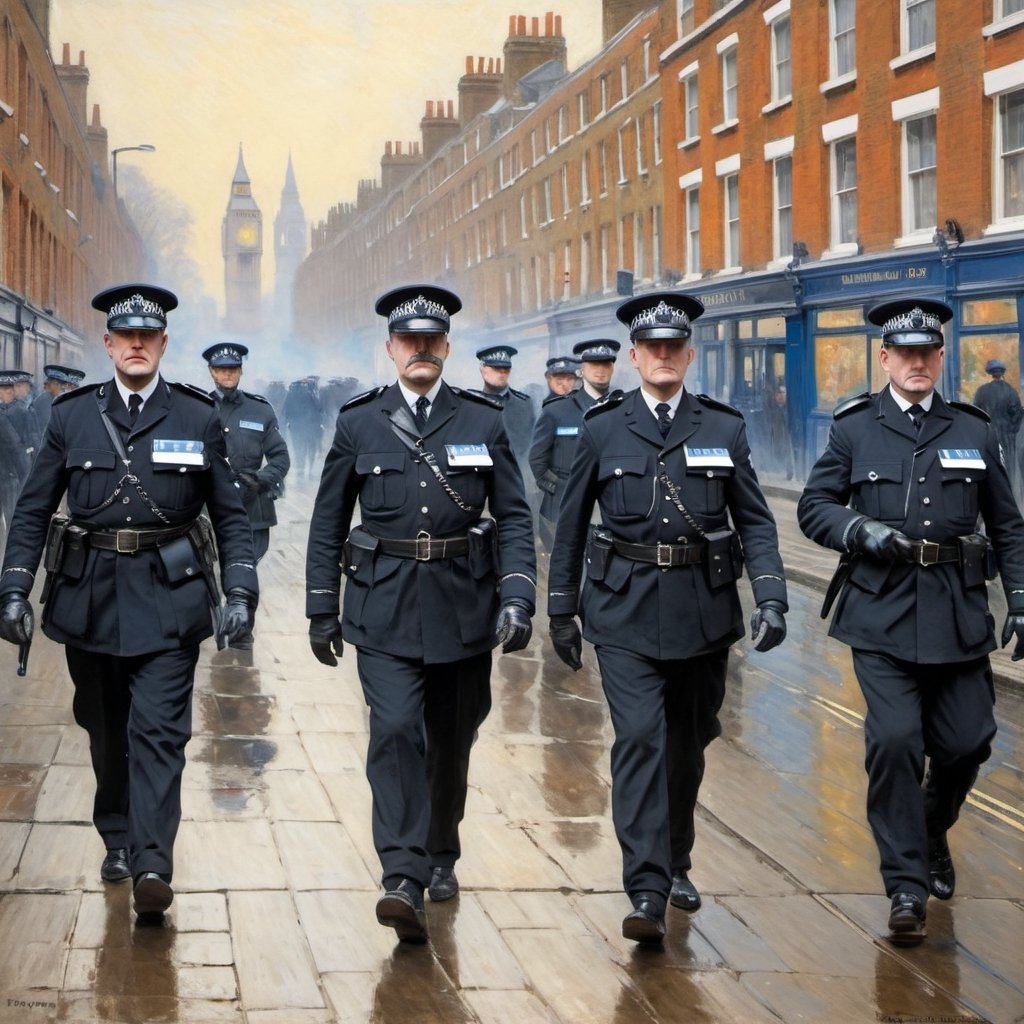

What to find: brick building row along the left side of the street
left=0, top=0, right=144, bottom=382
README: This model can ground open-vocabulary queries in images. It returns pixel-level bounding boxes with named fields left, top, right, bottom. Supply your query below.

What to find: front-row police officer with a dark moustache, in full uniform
left=306, top=285, right=537, bottom=942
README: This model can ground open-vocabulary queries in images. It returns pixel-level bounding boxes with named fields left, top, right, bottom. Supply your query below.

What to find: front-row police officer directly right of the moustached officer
left=548, top=292, right=786, bottom=942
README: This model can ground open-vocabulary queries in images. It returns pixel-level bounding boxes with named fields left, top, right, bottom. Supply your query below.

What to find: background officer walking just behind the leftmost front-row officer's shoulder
left=203, top=342, right=291, bottom=650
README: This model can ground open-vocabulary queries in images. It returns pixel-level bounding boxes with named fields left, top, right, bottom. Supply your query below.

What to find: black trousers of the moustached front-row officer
left=357, top=647, right=490, bottom=885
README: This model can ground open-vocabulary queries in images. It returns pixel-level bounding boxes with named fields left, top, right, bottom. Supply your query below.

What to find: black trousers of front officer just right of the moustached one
left=596, top=644, right=729, bottom=897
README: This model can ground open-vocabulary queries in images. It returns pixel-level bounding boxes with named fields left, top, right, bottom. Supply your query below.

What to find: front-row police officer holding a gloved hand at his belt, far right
left=797, top=296, right=1024, bottom=945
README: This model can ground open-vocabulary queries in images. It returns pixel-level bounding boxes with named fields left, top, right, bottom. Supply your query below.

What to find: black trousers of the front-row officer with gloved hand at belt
left=853, top=649, right=995, bottom=899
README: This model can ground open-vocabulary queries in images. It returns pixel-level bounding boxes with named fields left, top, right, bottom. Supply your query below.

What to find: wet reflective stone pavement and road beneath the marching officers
left=0, top=481, right=1024, bottom=1024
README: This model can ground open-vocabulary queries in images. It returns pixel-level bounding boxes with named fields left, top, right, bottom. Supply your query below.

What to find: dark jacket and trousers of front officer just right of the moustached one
left=548, top=390, right=786, bottom=896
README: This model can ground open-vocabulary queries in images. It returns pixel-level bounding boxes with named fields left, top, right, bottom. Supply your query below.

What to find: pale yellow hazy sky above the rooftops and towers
left=50, top=0, right=601, bottom=311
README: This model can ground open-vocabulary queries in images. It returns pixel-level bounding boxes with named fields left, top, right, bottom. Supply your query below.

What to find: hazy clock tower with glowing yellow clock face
left=220, top=144, right=263, bottom=336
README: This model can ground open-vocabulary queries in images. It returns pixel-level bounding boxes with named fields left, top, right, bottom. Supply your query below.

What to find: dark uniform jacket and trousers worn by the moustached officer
left=306, top=384, right=537, bottom=885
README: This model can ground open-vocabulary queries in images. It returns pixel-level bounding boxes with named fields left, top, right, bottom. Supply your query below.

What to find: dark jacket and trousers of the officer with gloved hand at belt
left=798, top=388, right=1024, bottom=899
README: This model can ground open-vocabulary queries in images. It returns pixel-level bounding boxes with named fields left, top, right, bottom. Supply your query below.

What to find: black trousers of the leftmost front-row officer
left=65, top=644, right=199, bottom=880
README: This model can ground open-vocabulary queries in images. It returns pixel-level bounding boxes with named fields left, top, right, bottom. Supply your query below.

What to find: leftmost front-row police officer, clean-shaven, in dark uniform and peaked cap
left=0, top=285, right=258, bottom=921
